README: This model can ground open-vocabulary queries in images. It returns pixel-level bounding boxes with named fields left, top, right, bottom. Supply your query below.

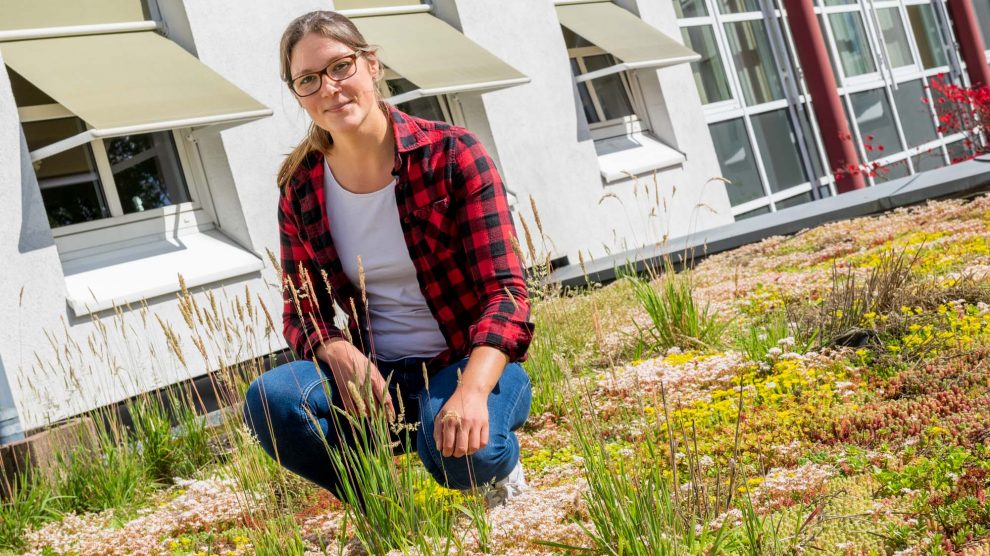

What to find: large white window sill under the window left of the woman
left=62, top=231, right=264, bottom=317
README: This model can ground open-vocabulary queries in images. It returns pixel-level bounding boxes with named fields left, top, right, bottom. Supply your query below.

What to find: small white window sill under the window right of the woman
left=595, top=132, right=686, bottom=183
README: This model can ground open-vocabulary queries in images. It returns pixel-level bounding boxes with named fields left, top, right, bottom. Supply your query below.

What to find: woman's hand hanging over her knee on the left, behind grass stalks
left=316, top=341, right=395, bottom=421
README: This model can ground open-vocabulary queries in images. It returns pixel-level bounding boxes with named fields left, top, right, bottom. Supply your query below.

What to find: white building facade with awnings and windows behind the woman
left=0, top=0, right=732, bottom=443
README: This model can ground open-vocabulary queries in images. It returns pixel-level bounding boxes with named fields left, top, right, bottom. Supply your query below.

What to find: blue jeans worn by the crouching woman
left=244, top=358, right=532, bottom=500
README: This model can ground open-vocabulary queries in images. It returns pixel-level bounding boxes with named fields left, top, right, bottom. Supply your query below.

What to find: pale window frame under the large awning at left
left=17, top=103, right=216, bottom=261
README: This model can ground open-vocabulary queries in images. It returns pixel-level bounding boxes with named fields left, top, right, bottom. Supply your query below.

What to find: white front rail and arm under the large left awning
left=31, top=108, right=272, bottom=162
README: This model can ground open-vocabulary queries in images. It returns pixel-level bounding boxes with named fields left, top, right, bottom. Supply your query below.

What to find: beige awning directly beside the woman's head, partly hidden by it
left=354, top=12, right=529, bottom=104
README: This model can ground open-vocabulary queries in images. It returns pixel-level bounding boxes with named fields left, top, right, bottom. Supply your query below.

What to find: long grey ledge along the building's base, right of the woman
left=549, top=155, right=990, bottom=287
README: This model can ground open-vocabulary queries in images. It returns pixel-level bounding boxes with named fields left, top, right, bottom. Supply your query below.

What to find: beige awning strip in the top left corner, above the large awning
left=0, top=0, right=147, bottom=31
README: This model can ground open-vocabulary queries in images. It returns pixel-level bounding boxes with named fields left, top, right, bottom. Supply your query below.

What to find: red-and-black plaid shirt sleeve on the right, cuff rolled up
left=454, top=131, right=534, bottom=361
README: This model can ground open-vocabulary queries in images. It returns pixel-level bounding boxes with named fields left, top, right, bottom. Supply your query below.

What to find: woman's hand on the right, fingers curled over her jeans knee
left=433, top=387, right=488, bottom=458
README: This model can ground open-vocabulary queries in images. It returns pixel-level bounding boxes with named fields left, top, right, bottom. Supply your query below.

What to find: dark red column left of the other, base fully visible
left=784, top=0, right=868, bottom=193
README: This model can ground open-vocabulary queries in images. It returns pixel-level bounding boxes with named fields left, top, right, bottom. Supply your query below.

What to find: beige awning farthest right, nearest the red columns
left=556, top=1, right=701, bottom=82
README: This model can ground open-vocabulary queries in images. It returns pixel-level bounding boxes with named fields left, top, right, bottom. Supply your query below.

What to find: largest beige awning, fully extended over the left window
left=0, top=31, right=272, bottom=160
